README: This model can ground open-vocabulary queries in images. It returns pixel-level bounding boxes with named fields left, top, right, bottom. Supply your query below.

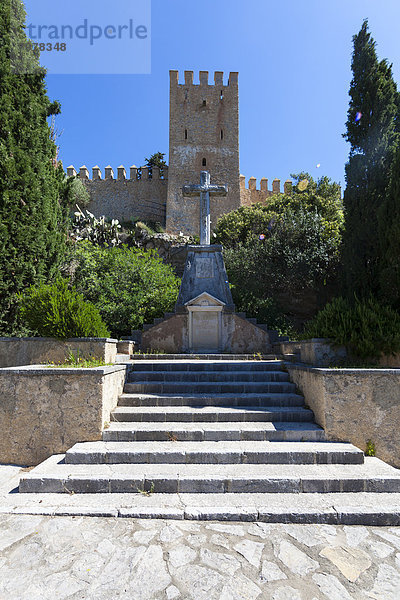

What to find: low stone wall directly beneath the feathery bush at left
left=0, top=337, right=117, bottom=368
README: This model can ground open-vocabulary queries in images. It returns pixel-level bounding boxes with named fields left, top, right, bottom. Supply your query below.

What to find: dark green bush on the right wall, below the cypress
left=302, top=298, right=400, bottom=359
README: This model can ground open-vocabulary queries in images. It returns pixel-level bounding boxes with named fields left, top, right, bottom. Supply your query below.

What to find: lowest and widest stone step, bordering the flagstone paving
left=10, top=492, right=400, bottom=527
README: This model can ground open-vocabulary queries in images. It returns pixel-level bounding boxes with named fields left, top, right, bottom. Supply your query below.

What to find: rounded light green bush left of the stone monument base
left=70, top=241, right=180, bottom=337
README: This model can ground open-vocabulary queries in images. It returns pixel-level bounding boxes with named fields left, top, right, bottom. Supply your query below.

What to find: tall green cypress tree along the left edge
left=0, top=0, right=69, bottom=335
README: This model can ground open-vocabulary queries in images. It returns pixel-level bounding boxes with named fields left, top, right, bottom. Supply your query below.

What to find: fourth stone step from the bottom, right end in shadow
left=103, top=422, right=325, bottom=442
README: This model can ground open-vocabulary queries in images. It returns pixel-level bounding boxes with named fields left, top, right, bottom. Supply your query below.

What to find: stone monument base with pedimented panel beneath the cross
left=141, top=245, right=271, bottom=354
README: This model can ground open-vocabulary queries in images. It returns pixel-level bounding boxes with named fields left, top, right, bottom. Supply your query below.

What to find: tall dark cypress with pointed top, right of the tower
left=343, top=21, right=399, bottom=298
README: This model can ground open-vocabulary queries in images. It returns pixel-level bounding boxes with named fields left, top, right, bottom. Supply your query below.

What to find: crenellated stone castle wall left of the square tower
left=67, top=165, right=168, bottom=226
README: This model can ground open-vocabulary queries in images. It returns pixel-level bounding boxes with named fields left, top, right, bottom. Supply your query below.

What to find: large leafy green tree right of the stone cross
left=215, top=173, right=343, bottom=333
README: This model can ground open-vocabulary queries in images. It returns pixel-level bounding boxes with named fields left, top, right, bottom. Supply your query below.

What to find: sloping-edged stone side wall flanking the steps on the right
left=286, top=363, right=400, bottom=468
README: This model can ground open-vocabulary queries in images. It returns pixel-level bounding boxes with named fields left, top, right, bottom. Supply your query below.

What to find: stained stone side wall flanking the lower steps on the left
left=0, top=365, right=126, bottom=466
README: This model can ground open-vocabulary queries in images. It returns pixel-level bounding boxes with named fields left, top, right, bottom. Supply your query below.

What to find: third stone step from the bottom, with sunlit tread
left=65, top=441, right=364, bottom=465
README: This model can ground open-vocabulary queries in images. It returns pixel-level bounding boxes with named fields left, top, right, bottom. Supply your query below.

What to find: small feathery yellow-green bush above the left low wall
left=20, top=279, right=110, bottom=340
